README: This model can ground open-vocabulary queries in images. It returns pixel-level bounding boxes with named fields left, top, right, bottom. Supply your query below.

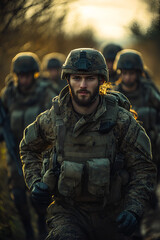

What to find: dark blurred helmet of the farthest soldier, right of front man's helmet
left=102, top=43, right=122, bottom=62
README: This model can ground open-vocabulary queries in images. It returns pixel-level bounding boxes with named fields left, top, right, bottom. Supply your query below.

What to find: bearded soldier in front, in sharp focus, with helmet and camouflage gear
left=20, top=48, right=156, bottom=240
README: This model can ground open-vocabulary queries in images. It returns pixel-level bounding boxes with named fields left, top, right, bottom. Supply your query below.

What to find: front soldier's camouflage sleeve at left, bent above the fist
left=20, top=109, right=54, bottom=189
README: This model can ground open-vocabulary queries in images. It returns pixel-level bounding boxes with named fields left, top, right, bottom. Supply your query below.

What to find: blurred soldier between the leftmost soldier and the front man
left=41, top=52, right=66, bottom=95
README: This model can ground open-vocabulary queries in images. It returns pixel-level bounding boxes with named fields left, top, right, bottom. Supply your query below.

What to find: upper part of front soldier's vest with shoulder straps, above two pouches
left=53, top=94, right=118, bottom=165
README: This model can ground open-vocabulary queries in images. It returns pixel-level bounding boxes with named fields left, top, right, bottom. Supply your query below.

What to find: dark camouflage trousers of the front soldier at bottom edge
left=46, top=203, right=126, bottom=240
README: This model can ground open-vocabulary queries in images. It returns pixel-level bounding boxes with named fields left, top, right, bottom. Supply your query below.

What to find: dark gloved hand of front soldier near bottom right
left=116, top=211, right=138, bottom=236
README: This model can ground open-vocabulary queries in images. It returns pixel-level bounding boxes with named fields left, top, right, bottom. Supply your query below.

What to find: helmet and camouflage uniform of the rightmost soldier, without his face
left=114, top=49, right=160, bottom=239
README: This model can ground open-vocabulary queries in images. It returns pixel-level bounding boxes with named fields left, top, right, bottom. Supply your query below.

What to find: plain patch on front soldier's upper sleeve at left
left=24, top=123, right=38, bottom=144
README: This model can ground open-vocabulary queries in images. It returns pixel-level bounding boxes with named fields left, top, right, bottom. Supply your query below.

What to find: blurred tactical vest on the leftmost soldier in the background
left=7, top=80, right=50, bottom=144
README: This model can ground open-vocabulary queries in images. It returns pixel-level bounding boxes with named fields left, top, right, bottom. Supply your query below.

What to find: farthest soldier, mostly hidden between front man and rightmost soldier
left=102, top=43, right=122, bottom=84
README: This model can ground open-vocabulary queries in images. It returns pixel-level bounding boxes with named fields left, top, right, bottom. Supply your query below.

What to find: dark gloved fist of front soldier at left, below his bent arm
left=31, top=182, right=52, bottom=207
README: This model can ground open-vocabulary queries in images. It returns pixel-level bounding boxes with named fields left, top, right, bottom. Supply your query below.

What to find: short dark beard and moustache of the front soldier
left=69, top=85, right=99, bottom=107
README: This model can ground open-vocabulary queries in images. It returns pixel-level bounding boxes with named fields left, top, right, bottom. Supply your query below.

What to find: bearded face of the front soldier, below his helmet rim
left=69, top=74, right=99, bottom=106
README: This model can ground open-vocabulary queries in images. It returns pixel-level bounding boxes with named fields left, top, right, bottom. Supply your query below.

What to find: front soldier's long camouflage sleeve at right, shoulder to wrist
left=119, top=109, right=156, bottom=216
